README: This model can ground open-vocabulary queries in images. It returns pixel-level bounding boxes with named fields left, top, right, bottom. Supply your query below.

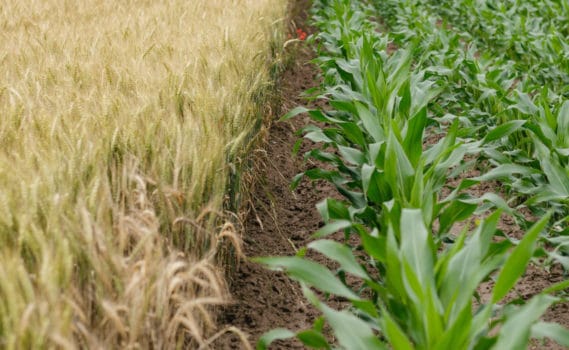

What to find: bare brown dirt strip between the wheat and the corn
left=213, top=0, right=328, bottom=349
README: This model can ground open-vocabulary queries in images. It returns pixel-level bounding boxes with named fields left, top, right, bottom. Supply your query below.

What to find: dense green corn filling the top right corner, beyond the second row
left=424, top=0, right=568, bottom=96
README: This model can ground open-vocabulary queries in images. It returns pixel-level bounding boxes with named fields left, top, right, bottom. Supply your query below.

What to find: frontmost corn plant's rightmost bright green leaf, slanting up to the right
left=492, top=213, right=551, bottom=303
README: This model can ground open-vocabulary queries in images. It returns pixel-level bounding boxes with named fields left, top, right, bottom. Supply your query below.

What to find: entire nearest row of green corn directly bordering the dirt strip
left=258, top=0, right=569, bottom=349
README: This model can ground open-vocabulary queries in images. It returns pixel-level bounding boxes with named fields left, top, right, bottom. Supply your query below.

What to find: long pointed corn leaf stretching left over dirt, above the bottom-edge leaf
left=253, top=257, right=360, bottom=300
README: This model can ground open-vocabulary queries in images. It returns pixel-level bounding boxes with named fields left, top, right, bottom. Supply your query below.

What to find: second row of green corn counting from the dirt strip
left=376, top=0, right=567, bottom=230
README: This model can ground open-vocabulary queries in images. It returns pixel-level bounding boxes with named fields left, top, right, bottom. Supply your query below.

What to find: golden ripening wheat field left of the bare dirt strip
left=0, top=0, right=286, bottom=349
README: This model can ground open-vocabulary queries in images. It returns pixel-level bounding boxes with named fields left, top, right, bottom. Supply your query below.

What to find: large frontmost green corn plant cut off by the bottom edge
left=258, top=208, right=569, bottom=350
